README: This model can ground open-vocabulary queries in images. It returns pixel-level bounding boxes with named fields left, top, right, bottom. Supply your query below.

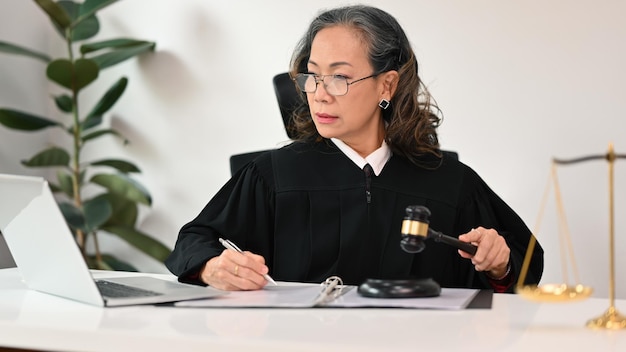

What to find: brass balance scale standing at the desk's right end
left=516, top=144, right=626, bottom=330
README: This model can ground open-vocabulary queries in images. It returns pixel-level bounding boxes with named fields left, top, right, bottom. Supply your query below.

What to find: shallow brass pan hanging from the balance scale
left=516, top=284, right=593, bottom=302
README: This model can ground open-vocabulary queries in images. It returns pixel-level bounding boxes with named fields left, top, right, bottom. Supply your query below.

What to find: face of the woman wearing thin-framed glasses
left=307, top=26, right=390, bottom=154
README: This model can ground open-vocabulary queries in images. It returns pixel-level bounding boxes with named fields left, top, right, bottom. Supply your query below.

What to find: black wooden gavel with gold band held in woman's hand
left=400, top=205, right=477, bottom=255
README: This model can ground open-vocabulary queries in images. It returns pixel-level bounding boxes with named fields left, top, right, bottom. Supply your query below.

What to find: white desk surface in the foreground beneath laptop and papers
left=0, top=268, right=626, bottom=352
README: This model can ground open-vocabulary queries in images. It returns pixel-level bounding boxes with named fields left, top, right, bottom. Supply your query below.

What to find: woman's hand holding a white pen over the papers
left=200, top=249, right=269, bottom=291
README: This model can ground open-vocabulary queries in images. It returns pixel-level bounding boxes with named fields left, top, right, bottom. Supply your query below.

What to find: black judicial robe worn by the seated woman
left=165, top=140, right=543, bottom=291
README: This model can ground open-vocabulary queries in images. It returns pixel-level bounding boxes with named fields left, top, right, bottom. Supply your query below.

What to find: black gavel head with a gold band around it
left=400, top=205, right=430, bottom=253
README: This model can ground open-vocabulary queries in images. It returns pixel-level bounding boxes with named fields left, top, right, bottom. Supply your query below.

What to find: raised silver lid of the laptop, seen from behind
left=0, top=174, right=102, bottom=305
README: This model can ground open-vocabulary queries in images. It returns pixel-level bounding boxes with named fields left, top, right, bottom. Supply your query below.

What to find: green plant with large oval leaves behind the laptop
left=0, top=0, right=170, bottom=270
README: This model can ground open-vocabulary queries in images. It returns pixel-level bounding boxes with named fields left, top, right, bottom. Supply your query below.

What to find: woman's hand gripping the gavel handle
left=459, top=227, right=511, bottom=278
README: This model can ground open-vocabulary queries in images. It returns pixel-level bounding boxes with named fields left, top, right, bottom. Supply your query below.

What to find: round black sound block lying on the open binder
left=357, top=278, right=441, bottom=298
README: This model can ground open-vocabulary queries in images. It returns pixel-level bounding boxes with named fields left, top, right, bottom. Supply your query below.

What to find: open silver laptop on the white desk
left=0, top=174, right=226, bottom=307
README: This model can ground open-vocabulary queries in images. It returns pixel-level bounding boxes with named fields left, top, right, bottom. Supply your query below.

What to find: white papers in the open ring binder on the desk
left=175, top=280, right=479, bottom=310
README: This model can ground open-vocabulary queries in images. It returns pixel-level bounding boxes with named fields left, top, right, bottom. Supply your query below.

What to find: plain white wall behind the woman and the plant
left=0, top=0, right=626, bottom=298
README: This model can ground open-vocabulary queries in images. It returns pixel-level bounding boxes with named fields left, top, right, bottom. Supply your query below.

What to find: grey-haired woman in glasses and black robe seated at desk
left=166, top=6, right=543, bottom=292
